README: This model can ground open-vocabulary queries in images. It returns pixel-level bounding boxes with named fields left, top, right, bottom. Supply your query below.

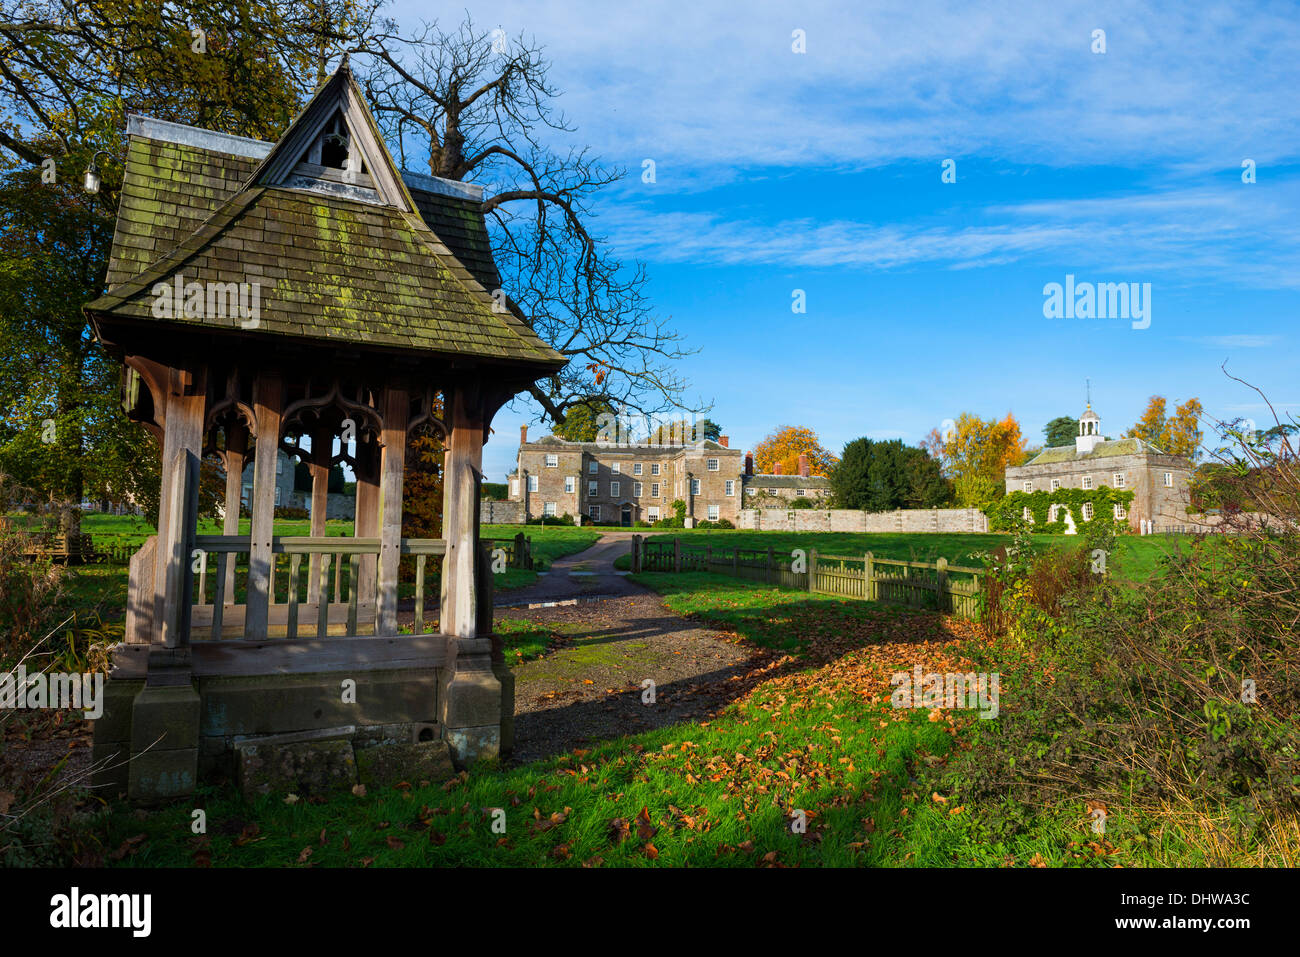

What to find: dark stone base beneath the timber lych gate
left=92, top=640, right=515, bottom=804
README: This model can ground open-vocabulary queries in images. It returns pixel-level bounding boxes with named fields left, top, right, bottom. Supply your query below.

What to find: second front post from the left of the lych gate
left=244, top=373, right=283, bottom=641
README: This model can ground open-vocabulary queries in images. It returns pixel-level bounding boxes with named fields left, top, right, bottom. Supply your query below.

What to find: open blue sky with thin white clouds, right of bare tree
left=389, top=0, right=1300, bottom=481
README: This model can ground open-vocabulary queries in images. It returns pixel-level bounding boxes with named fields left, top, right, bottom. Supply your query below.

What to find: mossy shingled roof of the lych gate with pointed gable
left=86, top=64, right=564, bottom=376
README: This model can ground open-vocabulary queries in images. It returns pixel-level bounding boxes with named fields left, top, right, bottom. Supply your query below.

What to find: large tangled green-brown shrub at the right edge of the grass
left=971, top=421, right=1300, bottom=843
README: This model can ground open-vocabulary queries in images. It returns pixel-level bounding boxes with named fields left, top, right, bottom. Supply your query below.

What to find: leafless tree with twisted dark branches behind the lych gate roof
left=355, top=17, right=701, bottom=423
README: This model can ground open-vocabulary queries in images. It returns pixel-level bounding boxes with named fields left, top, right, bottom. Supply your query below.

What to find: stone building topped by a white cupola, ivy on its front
left=1006, top=403, right=1193, bottom=531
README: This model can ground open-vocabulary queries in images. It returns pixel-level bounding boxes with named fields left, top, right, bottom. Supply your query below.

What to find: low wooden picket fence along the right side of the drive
left=632, top=536, right=984, bottom=620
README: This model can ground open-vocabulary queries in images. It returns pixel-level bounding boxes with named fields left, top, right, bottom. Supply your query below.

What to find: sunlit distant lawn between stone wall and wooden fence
left=615, top=528, right=1184, bottom=581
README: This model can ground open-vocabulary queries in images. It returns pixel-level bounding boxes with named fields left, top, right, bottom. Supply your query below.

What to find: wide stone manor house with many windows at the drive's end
left=510, top=425, right=831, bottom=528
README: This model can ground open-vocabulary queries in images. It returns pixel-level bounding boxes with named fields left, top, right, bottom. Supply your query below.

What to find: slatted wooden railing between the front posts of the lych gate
left=191, top=534, right=446, bottom=640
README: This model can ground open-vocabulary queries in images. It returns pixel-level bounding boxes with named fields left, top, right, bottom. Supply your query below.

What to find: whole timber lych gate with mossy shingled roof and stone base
left=86, top=64, right=564, bottom=800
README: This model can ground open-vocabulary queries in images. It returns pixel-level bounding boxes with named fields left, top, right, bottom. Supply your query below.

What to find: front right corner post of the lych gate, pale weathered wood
left=441, top=384, right=484, bottom=638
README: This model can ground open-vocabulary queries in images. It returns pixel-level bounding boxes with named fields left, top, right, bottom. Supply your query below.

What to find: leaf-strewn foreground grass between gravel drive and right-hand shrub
left=94, top=575, right=1227, bottom=867
